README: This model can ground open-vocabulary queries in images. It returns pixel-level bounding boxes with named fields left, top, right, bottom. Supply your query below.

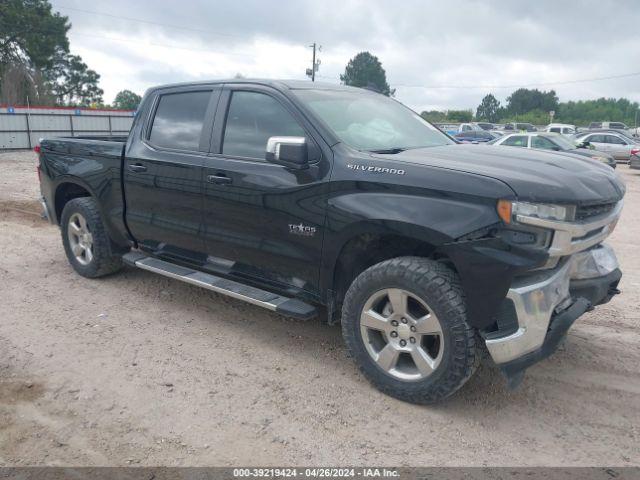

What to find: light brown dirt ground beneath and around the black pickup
left=0, top=152, right=640, bottom=466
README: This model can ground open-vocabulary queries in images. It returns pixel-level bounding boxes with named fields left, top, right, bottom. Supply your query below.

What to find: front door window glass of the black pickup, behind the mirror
left=222, top=91, right=305, bottom=160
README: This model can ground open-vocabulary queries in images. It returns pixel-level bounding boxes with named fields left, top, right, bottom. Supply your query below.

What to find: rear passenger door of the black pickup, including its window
left=123, top=86, right=221, bottom=263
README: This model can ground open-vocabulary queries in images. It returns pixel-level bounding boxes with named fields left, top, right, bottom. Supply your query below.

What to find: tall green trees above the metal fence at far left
left=0, top=0, right=103, bottom=105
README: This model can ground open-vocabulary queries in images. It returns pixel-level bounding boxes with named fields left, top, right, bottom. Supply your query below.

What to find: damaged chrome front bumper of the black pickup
left=486, top=245, right=618, bottom=364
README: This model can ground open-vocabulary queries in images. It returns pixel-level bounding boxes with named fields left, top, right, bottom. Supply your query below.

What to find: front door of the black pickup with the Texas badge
left=203, top=84, right=330, bottom=297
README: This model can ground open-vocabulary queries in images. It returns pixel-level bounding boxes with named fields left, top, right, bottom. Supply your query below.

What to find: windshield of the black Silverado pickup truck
left=294, top=89, right=455, bottom=151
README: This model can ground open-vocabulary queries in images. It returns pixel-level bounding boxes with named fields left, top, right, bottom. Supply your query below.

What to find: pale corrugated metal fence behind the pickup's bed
left=0, top=109, right=133, bottom=150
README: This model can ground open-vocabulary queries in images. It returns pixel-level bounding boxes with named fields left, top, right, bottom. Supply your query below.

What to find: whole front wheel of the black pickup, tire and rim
left=342, top=257, right=479, bottom=404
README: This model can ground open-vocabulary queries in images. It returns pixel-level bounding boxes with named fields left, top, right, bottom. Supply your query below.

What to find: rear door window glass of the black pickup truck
left=149, top=91, right=211, bottom=151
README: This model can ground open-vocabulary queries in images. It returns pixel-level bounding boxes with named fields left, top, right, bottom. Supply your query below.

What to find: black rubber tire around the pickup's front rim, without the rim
left=342, top=257, right=480, bottom=404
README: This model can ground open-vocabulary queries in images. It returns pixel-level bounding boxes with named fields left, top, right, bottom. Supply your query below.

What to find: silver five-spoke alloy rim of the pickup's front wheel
left=360, top=288, right=444, bottom=381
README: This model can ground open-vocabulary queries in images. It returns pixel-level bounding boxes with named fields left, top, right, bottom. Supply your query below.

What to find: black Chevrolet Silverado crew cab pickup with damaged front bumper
left=39, top=80, right=625, bottom=403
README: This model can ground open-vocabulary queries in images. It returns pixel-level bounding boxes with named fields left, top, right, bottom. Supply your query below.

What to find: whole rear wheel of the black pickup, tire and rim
left=60, top=197, right=122, bottom=278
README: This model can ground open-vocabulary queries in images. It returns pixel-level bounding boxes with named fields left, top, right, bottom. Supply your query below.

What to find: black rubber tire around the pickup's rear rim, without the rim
left=60, top=197, right=122, bottom=278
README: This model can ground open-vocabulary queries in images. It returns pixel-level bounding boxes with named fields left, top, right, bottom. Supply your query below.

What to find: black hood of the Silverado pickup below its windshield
left=374, top=144, right=625, bottom=205
